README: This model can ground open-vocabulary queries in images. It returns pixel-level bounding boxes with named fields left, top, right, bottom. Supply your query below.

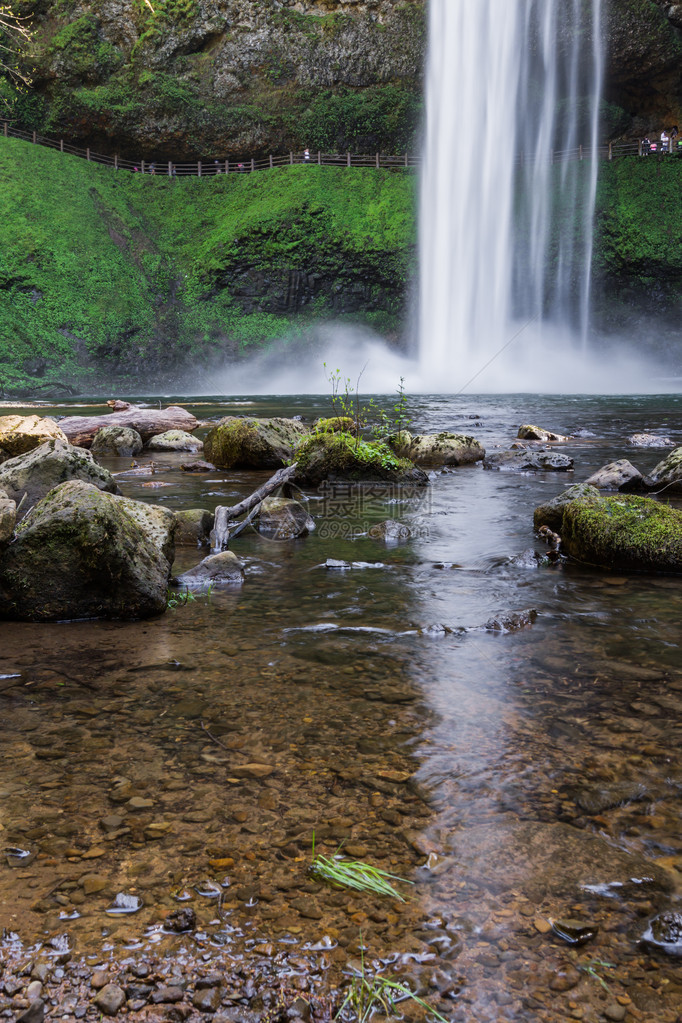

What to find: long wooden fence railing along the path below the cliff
left=0, top=121, right=682, bottom=178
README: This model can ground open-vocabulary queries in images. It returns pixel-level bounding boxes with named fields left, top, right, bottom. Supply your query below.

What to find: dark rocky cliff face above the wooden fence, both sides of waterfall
left=9, top=0, right=682, bottom=160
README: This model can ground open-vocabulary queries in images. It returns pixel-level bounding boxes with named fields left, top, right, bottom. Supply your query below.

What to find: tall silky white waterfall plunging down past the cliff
left=419, top=0, right=603, bottom=391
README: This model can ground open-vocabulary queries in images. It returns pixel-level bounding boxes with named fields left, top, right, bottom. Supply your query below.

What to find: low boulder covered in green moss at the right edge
left=560, top=494, right=682, bottom=573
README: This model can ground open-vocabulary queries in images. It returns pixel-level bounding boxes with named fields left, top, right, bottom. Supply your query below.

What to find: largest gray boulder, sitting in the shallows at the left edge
left=0, top=480, right=175, bottom=621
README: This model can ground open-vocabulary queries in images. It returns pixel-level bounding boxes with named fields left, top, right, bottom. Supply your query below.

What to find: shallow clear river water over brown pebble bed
left=0, top=396, right=682, bottom=1023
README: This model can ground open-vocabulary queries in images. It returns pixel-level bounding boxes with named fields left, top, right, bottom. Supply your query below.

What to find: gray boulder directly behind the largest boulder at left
left=0, top=438, right=118, bottom=515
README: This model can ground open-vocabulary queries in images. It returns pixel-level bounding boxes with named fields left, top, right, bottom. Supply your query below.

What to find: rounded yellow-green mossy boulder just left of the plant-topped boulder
left=203, top=415, right=310, bottom=469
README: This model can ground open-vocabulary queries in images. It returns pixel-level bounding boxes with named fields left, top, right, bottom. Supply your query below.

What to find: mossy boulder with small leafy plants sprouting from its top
left=295, top=432, right=428, bottom=487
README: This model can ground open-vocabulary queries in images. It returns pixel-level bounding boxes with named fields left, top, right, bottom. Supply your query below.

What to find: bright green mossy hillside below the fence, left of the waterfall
left=0, top=138, right=415, bottom=390
